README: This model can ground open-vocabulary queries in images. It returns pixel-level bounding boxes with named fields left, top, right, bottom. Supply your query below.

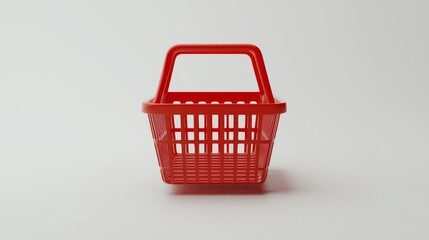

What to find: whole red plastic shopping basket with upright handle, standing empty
left=143, top=44, right=286, bottom=184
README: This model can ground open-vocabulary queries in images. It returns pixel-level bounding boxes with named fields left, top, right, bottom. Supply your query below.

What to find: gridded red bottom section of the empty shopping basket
left=161, top=154, right=268, bottom=184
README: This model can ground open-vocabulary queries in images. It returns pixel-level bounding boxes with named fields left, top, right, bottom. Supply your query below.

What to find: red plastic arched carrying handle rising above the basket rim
left=154, top=44, right=274, bottom=103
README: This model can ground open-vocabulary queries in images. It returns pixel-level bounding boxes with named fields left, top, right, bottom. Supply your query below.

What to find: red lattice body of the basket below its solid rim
left=149, top=101, right=279, bottom=183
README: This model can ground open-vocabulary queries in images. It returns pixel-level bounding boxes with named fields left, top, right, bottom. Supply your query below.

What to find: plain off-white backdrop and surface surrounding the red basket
left=0, top=0, right=429, bottom=240
